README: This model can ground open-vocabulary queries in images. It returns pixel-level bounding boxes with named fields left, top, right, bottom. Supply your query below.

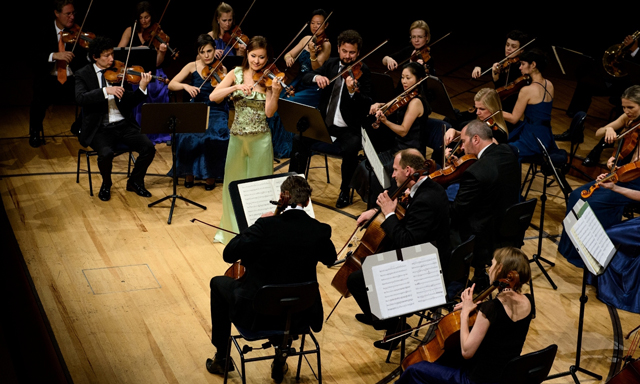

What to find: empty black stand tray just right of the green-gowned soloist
left=278, top=99, right=333, bottom=144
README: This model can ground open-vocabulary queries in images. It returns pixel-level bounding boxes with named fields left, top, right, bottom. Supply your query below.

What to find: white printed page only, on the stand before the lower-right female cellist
left=371, top=254, right=446, bottom=319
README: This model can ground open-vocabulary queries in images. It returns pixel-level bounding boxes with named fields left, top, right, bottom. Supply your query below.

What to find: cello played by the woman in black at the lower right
left=401, top=271, right=520, bottom=370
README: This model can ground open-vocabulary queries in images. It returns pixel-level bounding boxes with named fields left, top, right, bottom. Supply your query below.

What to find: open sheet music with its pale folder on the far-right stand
left=563, top=200, right=616, bottom=275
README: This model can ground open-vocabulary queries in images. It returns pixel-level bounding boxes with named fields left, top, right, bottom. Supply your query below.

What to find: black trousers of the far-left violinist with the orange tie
left=29, top=76, right=76, bottom=135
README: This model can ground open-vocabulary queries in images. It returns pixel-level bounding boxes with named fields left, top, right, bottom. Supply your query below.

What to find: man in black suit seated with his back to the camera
left=206, top=176, right=336, bottom=382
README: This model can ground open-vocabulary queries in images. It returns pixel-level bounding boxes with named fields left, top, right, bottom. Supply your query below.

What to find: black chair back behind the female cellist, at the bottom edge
left=499, top=344, right=558, bottom=384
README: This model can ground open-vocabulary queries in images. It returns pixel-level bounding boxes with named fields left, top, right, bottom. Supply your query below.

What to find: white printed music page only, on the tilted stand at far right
left=571, top=209, right=615, bottom=266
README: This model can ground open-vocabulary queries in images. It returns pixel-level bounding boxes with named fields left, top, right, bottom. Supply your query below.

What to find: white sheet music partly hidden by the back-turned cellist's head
left=238, top=174, right=315, bottom=226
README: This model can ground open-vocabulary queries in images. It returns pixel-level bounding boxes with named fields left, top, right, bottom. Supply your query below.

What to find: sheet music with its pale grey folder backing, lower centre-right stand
left=362, top=243, right=447, bottom=319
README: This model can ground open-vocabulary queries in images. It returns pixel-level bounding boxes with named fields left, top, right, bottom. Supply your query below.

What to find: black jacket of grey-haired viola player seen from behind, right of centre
left=450, top=144, right=520, bottom=260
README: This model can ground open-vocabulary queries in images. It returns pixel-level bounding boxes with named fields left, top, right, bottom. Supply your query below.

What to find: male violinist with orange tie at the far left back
left=29, top=0, right=89, bottom=148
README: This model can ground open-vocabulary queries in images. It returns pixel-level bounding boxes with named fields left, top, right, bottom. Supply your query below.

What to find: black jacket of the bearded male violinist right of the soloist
left=302, top=57, right=373, bottom=135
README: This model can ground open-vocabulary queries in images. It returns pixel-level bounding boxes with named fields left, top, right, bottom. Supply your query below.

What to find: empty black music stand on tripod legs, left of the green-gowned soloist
left=141, top=103, right=209, bottom=224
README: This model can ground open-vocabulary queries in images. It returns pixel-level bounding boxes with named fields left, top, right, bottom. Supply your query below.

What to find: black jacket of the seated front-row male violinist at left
left=76, top=65, right=147, bottom=147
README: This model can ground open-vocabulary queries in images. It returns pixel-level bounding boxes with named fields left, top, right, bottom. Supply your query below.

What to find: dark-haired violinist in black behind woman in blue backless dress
left=471, top=29, right=529, bottom=112
